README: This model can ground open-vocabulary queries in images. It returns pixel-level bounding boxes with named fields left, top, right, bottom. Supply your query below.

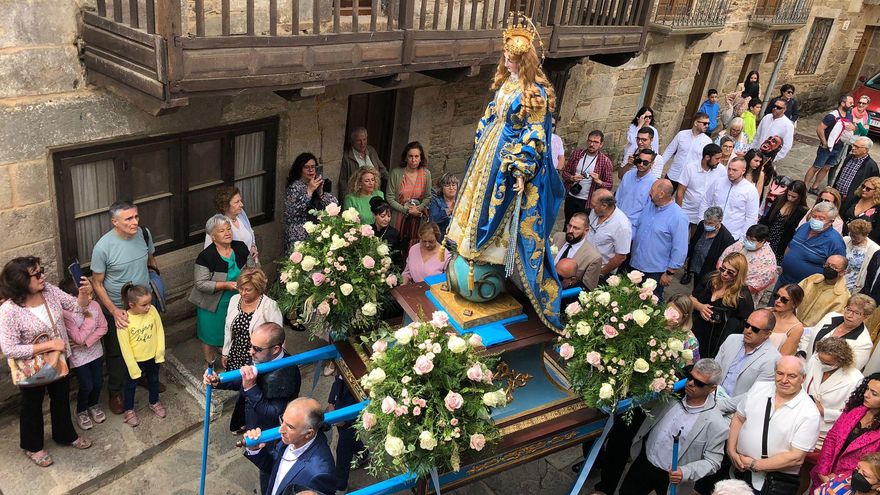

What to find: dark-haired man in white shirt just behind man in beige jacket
left=587, top=189, right=632, bottom=277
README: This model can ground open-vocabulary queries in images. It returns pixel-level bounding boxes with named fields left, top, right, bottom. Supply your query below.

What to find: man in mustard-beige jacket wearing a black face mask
left=797, top=254, right=849, bottom=327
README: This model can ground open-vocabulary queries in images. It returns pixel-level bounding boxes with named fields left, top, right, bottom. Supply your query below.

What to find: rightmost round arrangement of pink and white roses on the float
left=559, top=271, right=693, bottom=411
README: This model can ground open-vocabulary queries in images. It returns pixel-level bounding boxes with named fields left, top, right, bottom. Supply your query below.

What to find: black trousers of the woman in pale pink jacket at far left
left=19, top=377, right=79, bottom=452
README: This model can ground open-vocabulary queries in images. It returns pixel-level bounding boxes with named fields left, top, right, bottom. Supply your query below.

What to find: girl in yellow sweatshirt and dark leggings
left=116, top=283, right=167, bottom=427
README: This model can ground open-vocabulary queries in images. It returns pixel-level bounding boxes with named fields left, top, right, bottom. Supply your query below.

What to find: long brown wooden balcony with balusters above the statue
left=82, top=0, right=652, bottom=114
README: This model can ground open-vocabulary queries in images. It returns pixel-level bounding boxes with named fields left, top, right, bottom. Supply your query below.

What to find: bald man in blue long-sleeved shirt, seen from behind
left=629, top=179, right=688, bottom=299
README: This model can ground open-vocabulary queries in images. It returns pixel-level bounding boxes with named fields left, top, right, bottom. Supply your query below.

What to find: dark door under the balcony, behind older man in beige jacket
left=345, top=91, right=403, bottom=170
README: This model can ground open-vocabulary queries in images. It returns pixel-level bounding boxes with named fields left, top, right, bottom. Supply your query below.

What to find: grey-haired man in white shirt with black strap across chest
left=727, top=356, right=821, bottom=493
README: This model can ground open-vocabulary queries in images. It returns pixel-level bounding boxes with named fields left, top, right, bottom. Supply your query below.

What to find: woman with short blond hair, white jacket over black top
left=797, top=294, right=877, bottom=370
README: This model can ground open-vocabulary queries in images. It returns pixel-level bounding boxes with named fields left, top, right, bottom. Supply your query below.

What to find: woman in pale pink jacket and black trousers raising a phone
left=0, top=256, right=92, bottom=467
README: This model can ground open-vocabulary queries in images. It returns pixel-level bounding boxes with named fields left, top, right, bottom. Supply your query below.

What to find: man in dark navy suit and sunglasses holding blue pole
left=203, top=322, right=302, bottom=494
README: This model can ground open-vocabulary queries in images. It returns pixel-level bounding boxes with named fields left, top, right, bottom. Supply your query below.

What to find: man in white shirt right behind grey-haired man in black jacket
left=700, top=157, right=759, bottom=240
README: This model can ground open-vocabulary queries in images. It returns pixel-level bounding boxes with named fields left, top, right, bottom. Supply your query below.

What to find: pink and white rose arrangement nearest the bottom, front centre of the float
left=357, top=311, right=507, bottom=476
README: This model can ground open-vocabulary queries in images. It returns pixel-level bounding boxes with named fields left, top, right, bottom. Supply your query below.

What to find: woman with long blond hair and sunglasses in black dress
left=691, top=253, right=755, bottom=358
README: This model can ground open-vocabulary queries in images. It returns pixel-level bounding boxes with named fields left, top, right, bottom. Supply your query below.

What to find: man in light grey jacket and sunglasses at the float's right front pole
left=619, top=358, right=728, bottom=495
